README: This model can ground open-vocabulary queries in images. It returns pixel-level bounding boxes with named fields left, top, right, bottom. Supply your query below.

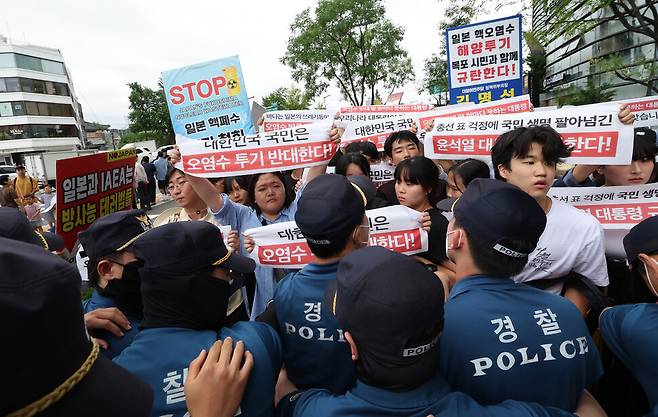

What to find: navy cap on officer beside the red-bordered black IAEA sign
left=78, top=210, right=151, bottom=260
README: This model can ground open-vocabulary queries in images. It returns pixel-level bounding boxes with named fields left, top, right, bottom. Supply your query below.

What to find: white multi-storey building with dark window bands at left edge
left=0, top=35, right=82, bottom=164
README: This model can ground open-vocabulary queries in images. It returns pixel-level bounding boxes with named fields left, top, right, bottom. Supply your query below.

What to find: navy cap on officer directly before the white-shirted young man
left=437, top=178, right=546, bottom=258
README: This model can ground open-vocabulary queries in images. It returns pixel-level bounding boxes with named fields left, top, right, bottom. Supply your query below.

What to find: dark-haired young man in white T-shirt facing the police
left=491, top=126, right=609, bottom=316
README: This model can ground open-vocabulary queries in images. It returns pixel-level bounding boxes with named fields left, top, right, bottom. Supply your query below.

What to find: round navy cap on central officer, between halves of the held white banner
left=295, top=174, right=367, bottom=245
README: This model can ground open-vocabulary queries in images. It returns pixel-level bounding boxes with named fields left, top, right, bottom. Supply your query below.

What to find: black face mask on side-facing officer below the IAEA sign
left=97, top=260, right=143, bottom=318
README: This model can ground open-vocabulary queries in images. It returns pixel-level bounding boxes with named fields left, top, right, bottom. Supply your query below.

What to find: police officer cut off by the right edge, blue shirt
left=600, top=216, right=658, bottom=415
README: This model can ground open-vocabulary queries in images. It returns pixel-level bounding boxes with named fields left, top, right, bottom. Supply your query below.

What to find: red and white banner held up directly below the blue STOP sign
left=176, top=119, right=337, bottom=177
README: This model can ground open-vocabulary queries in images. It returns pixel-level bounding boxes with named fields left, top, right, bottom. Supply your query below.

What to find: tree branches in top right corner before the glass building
left=532, top=0, right=658, bottom=95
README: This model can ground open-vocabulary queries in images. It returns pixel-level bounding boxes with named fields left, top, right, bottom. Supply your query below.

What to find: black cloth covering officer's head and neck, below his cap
left=140, top=269, right=230, bottom=331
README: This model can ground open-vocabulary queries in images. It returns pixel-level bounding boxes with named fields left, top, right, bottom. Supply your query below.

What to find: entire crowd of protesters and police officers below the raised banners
left=0, top=103, right=658, bottom=417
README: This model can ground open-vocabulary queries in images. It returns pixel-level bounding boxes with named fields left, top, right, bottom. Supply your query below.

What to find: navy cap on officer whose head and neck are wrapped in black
left=132, top=221, right=256, bottom=274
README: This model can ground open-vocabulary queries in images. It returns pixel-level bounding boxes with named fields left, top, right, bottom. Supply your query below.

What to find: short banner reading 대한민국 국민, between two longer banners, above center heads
left=340, top=115, right=415, bottom=152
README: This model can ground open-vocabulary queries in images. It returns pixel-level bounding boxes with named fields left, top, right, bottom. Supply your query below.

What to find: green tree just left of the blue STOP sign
left=122, top=80, right=174, bottom=146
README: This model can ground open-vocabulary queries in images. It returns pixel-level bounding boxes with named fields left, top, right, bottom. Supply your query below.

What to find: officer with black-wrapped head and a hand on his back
left=114, top=222, right=281, bottom=417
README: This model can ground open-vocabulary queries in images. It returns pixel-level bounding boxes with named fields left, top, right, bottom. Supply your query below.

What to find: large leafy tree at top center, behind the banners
left=281, top=0, right=414, bottom=106
